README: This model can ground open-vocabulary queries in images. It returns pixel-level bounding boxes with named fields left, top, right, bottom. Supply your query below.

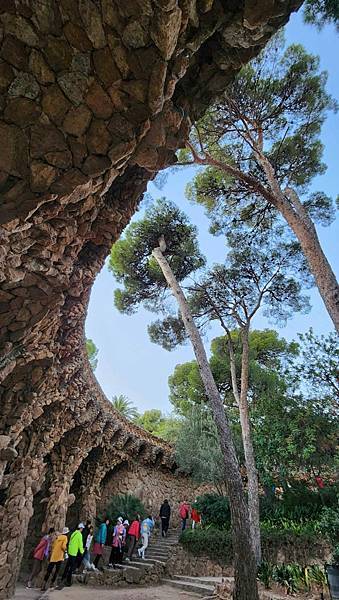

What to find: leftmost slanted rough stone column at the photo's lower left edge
left=0, top=457, right=45, bottom=600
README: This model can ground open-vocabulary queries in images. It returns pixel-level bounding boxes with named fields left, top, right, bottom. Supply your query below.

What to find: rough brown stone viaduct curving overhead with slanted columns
left=0, top=0, right=300, bottom=599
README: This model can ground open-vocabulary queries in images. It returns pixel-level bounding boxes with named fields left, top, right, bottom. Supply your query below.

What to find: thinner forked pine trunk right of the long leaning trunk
left=226, top=327, right=261, bottom=565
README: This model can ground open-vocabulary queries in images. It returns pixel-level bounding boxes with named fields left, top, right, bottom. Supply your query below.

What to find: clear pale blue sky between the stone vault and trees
left=86, top=13, right=339, bottom=413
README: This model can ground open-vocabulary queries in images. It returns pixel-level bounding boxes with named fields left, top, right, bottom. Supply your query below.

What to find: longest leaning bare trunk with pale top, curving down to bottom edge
left=152, top=248, right=258, bottom=600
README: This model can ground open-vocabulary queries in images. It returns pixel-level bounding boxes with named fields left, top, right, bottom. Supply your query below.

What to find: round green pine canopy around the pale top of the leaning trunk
left=109, top=198, right=205, bottom=314
